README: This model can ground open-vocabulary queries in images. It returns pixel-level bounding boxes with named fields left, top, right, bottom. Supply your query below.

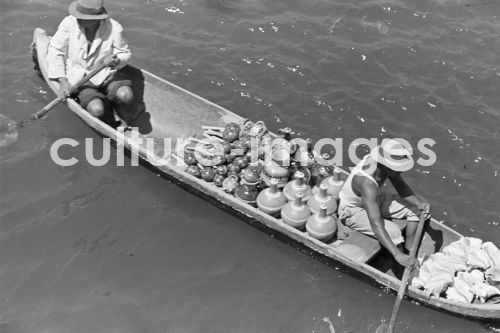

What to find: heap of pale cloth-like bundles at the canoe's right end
left=412, top=237, right=500, bottom=303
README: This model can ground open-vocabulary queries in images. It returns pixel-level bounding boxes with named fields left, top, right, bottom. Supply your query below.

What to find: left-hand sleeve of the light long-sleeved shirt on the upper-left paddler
left=47, top=18, right=70, bottom=79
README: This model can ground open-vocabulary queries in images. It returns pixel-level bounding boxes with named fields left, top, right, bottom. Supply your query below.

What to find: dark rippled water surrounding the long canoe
left=0, top=0, right=500, bottom=332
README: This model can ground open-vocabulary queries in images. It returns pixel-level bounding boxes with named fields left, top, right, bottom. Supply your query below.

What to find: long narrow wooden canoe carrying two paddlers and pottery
left=34, top=28, right=500, bottom=319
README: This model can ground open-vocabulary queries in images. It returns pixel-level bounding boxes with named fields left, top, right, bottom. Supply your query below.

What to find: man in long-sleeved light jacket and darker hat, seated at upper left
left=47, top=0, right=133, bottom=119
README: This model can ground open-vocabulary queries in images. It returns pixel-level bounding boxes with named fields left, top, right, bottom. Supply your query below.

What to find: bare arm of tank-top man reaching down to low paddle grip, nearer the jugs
left=359, top=179, right=417, bottom=267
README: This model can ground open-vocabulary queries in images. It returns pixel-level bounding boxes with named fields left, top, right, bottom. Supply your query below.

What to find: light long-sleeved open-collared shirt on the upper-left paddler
left=47, top=15, right=130, bottom=85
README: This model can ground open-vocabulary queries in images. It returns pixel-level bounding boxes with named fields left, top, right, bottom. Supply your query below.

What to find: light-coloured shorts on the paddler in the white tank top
left=339, top=192, right=419, bottom=245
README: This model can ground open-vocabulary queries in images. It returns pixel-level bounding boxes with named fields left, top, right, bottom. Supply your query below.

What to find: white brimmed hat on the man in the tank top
left=370, top=139, right=414, bottom=172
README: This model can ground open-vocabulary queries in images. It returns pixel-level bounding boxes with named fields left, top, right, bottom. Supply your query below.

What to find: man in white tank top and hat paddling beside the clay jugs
left=339, top=139, right=430, bottom=267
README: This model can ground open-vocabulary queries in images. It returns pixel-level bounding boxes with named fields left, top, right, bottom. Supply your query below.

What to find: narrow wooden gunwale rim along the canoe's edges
left=34, top=28, right=500, bottom=320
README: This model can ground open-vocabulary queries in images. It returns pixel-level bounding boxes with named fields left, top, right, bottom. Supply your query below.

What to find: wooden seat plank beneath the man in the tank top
left=330, top=220, right=407, bottom=263
